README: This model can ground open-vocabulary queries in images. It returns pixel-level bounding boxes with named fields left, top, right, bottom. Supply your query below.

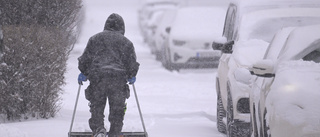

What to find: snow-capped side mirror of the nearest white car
left=250, top=59, right=275, bottom=78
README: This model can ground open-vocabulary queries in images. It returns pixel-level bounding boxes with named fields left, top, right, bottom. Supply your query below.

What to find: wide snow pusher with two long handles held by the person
left=68, top=84, right=148, bottom=137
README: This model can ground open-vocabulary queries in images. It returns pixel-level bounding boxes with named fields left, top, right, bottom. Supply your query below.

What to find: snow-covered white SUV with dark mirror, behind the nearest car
left=213, top=0, right=320, bottom=136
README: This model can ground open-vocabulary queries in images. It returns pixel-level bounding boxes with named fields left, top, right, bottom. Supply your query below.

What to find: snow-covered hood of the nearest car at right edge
left=266, top=60, right=320, bottom=129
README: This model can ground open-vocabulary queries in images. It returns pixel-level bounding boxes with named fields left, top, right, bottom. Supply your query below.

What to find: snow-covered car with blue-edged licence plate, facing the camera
left=161, top=6, right=225, bottom=70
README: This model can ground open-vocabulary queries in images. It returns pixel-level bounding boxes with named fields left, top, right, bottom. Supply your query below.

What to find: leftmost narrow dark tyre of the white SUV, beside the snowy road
left=216, top=80, right=227, bottom=134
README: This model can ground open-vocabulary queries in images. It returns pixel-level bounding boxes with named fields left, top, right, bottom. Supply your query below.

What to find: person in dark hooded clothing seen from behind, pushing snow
left=78, top=13, right=140, bottom=137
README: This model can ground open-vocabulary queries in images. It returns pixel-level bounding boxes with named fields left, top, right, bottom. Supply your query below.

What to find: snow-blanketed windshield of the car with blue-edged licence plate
left=171, top=6, right=225, bottom=39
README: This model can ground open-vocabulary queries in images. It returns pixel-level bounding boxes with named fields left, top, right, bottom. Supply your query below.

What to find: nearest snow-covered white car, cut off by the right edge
left=250, top=25, right=320, bottom=137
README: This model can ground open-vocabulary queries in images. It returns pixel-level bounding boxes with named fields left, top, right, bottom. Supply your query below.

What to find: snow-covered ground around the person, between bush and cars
left=0, top=0, right=225, bottom=137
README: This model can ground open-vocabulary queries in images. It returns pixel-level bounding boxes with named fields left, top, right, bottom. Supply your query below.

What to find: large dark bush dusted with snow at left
left=0, top=0, right=81, bottom=120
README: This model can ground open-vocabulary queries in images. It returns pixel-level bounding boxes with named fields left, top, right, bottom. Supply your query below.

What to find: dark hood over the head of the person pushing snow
left=104, top=13, right=125, bottom=35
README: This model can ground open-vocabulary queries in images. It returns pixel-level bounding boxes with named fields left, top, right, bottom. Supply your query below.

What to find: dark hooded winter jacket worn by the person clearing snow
left=78, top=13, right=139, bottom=80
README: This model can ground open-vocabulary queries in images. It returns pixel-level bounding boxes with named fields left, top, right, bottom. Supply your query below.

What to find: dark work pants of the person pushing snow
left=85, top=78, right=129, bottom=137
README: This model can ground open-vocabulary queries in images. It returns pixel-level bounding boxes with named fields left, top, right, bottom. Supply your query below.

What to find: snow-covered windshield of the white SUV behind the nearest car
left=238, top=8, right=320, bottom=42
